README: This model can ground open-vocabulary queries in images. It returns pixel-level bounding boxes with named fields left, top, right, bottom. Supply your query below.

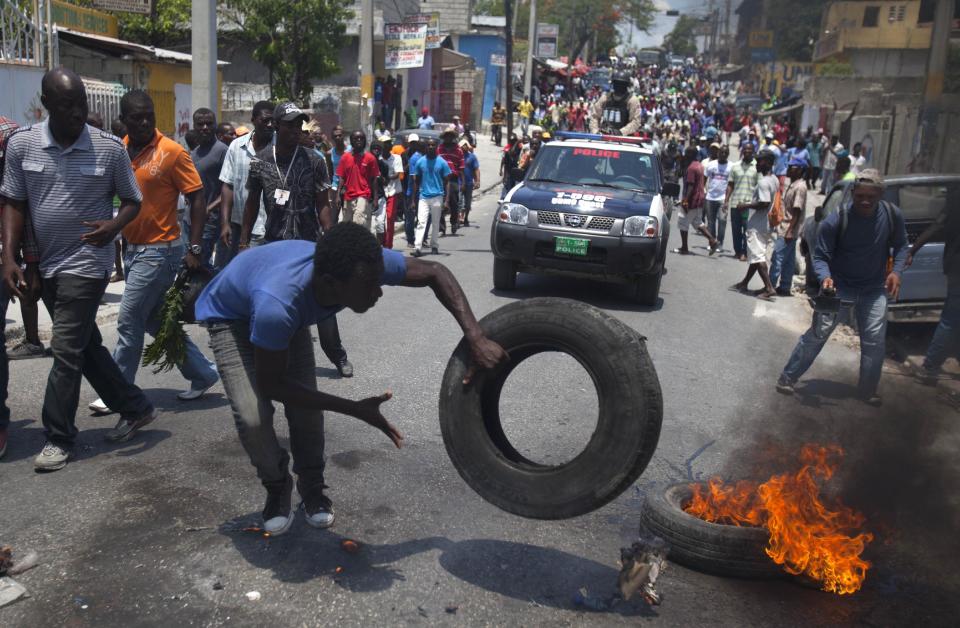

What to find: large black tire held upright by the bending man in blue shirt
left=440, top=298, right=663, bottom=519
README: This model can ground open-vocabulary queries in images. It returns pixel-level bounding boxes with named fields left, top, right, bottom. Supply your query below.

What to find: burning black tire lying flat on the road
left=641, top=482, right=786, bottom=579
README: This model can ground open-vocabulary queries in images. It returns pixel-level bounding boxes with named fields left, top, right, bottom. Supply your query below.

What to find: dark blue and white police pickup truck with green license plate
left=490, top=132, right=680, bottom=305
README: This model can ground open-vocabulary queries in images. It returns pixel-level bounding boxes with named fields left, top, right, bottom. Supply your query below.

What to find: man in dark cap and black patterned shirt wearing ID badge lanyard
left=240, top=102, right=353, bottom=377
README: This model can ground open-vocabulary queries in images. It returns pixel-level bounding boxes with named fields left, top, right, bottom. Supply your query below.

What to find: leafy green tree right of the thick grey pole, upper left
left=232, top=0, right=352, bottom=105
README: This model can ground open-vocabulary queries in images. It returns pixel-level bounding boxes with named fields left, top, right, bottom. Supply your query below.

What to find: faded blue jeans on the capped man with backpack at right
left=783, top=287, right=887, bottom=397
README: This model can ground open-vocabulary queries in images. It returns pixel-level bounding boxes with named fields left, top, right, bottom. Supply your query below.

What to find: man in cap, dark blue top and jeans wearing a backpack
left=777, top=168, right=908, bottom=406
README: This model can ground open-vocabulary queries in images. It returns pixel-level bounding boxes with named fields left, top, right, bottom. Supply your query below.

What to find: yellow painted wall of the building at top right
left=823, top=0, right=931, bottom=49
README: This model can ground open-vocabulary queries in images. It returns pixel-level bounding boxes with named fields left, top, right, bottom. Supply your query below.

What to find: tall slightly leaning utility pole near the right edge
left=918, top=0, right=954, bottom=172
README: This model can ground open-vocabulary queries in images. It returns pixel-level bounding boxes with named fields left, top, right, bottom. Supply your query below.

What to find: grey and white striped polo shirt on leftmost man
left=0, top=120, right=142, bottom=278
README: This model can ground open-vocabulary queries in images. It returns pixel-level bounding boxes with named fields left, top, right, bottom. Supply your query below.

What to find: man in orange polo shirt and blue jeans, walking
left=90, top=90, right=220, bottom=413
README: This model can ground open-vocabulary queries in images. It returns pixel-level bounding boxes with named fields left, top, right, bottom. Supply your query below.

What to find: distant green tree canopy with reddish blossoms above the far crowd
left=474, top=0, right=657, bottom=61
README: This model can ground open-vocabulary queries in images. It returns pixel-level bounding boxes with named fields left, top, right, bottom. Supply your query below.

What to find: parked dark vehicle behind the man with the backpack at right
left=800, top=174, right=960, bottom=322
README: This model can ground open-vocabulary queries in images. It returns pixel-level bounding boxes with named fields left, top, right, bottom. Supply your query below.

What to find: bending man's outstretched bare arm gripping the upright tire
left=400, top=258, right=510, bottom=384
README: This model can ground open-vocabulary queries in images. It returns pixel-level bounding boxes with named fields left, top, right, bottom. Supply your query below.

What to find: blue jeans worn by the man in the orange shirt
left=113, top=244, right=219, bottom=388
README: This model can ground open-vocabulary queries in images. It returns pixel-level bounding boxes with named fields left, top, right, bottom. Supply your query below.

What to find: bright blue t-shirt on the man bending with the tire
left=196, top=240, right=407, bottom=351
